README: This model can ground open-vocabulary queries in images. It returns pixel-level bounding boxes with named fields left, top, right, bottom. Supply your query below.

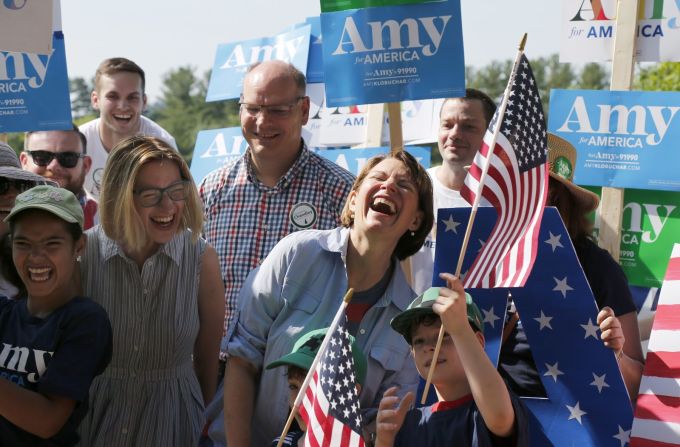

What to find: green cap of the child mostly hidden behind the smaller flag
left=267, top=328, right=367, bottom=384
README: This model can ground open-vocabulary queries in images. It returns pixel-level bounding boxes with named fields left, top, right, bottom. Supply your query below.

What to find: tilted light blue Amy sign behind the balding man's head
left=205, top=25, right=312, bottom=102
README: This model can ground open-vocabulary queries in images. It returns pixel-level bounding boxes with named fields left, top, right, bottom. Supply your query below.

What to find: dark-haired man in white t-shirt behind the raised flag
left=410, top=88, right=496, bottom=294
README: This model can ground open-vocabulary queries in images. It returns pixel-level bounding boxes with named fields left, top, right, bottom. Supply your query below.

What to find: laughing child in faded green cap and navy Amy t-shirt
left=0, top=185, right=112, bottom=447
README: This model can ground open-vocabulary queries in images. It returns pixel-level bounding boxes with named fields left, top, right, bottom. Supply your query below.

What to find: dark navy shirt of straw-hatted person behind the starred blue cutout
left=498, top=239, right=636, bottom=397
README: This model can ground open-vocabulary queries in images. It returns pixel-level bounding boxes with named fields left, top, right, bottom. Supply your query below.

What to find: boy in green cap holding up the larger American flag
left=375, top=273, right=529, bottom=447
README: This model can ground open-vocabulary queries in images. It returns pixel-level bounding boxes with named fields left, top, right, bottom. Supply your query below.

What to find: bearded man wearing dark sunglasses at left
left=19, top=125, right=99, bottom=230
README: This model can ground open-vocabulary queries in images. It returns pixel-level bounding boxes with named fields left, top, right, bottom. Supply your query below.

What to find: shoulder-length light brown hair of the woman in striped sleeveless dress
left=99, top=136, right=203, bottom=251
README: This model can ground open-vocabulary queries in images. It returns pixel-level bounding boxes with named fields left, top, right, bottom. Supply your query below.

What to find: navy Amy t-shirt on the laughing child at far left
left=0, top=297, right=112, bottom=447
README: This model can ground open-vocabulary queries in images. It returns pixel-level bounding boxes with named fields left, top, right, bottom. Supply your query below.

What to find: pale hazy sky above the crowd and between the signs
left=61, top=0, right=562, bottom=102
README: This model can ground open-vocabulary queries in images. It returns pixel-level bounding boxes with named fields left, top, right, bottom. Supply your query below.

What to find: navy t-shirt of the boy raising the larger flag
left=394, top=392, right=529, bottom=447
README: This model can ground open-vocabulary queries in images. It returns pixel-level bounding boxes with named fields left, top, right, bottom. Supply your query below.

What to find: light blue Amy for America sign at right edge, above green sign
left=548, top=90, right=680, bottom=191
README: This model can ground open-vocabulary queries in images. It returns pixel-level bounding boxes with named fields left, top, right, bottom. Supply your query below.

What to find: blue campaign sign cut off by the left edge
left=0, top=31, right=72, bottom=132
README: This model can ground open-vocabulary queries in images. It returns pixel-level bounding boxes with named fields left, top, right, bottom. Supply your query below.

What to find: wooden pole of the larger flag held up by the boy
left=420, top=33, right=527, bottom=405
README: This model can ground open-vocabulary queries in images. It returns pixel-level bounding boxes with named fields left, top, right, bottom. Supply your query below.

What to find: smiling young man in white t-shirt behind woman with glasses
left=80, top=57, right=177, bottom=199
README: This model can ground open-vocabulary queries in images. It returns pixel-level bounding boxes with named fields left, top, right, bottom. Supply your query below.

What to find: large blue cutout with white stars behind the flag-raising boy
left=434, top=207, right=633, bottom=447
